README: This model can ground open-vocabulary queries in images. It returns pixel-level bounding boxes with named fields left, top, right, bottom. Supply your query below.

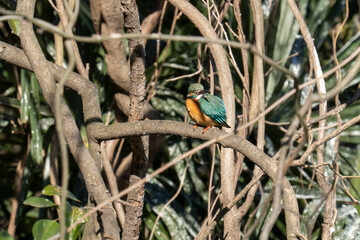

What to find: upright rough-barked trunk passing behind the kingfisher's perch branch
left=121, top=0, right=149, bottom=239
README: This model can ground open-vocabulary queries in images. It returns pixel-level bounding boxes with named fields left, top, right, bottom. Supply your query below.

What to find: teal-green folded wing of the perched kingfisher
left=199, top=93, right=226, bottom=124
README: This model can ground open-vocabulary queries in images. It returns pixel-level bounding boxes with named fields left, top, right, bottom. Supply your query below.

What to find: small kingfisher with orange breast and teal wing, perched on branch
left=185, top=83, right=230, bottom=133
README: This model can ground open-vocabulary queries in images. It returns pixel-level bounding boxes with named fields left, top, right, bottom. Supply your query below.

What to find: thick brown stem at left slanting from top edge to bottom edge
left=8, top=0, right=118, bottom=235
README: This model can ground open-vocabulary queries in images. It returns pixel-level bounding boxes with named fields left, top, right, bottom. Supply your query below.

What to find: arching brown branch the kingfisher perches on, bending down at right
left=93, top=120, right=300, bottom=239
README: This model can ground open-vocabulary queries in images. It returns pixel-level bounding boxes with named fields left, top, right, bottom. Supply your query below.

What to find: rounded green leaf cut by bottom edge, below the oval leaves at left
left=32, top=219, right=60, bottom=240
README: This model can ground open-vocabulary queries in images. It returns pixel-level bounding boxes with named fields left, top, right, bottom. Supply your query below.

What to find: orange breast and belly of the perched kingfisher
left=185, top=98, right=221, bottom=127
